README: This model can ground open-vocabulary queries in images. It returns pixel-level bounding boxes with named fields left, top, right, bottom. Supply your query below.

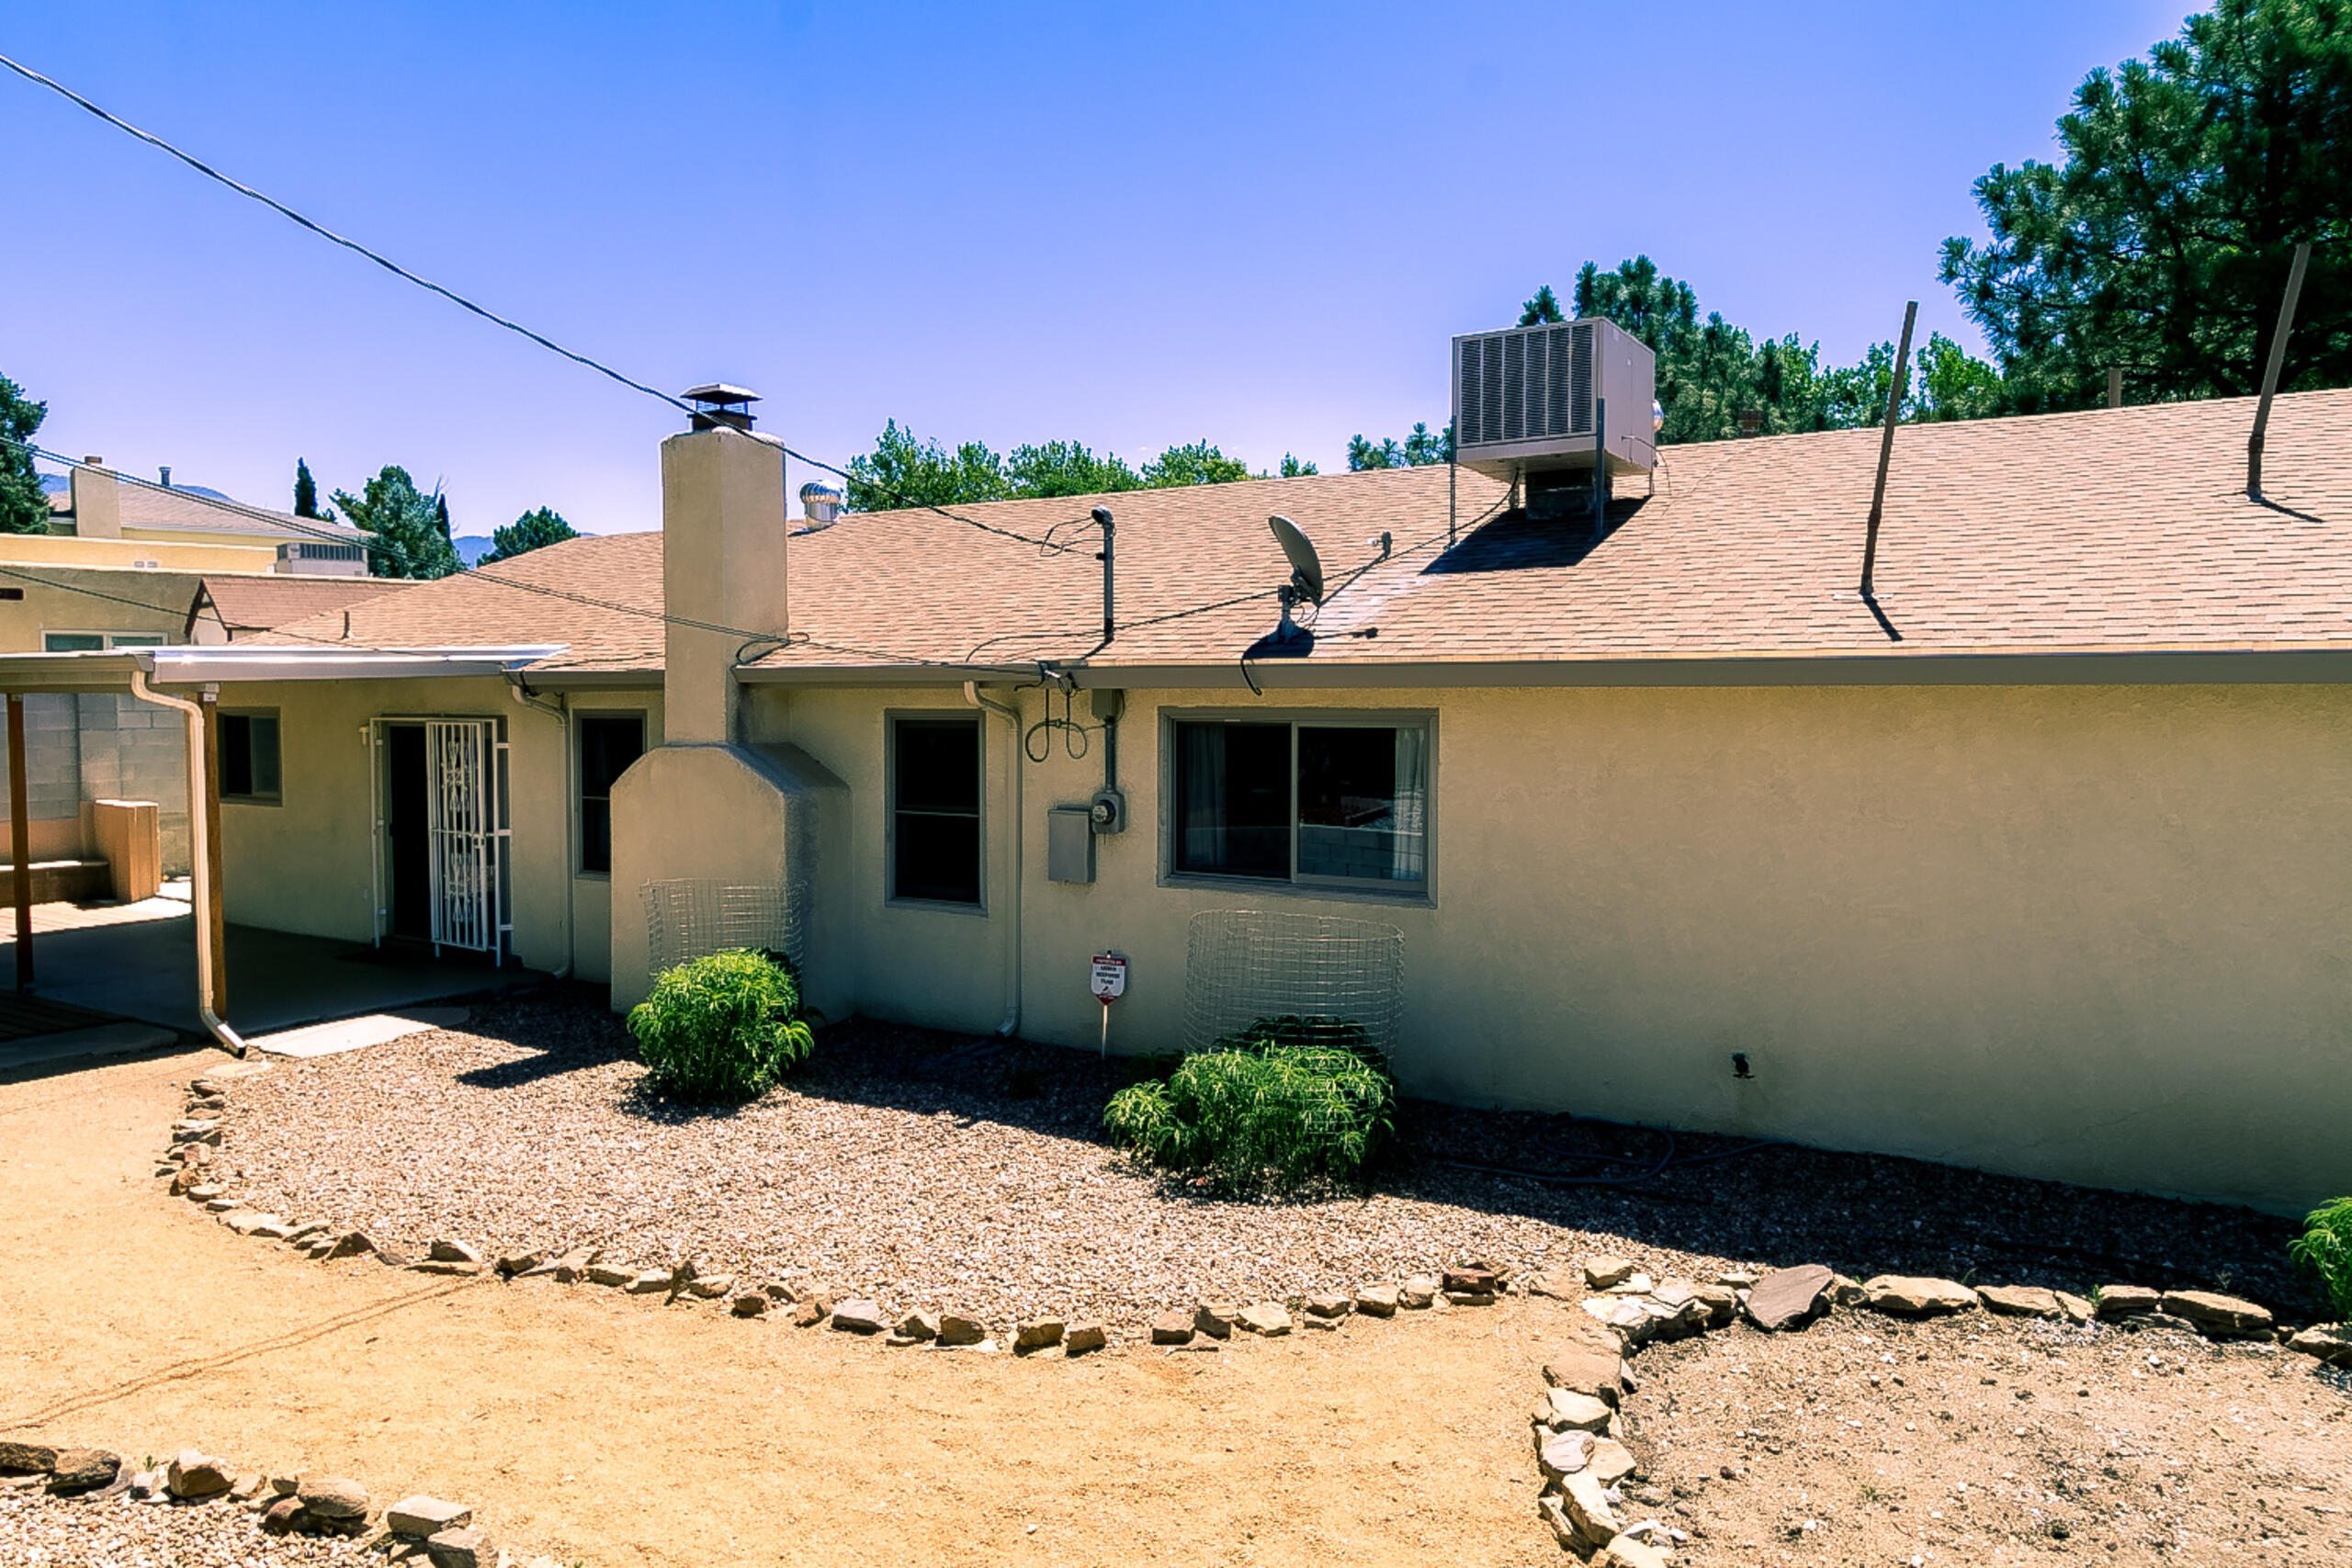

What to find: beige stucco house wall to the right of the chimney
left=755, top=686, right=2352, bottom=1211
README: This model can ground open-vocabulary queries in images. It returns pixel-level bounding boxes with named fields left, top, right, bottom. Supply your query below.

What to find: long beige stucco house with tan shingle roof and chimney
left=0, top=392, right=2352, bottom=1211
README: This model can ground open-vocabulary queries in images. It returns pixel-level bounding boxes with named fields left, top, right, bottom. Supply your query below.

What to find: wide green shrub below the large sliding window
left=1103, top=1018, right=1397, bottom=1185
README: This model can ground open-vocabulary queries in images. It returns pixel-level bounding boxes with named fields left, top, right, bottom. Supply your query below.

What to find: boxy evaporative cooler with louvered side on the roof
left=1453, top=317, right=1658, bottom=482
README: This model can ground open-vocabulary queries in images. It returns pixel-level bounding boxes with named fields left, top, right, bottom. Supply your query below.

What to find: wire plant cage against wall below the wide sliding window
left=1183, top=909, right=1404, bottom=1055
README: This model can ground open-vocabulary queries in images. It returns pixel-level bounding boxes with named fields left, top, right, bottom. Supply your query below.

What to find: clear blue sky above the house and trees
left=0, top=0, right=2185, bottom=534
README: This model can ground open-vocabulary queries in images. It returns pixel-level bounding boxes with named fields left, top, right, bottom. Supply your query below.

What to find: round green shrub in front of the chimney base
left=628, top=952, right=816, bottom=1100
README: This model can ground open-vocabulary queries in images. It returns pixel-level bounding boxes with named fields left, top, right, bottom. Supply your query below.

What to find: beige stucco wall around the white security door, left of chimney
left=221, top=680, right=661, bottom=980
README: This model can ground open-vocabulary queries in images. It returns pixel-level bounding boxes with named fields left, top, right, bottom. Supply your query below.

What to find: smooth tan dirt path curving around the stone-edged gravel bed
left=0, top=1054, right=1559, bottom=1568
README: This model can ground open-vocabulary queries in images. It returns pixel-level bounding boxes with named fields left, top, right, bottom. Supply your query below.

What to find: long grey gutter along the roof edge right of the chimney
left=736, top=644, right=2352, bottom=691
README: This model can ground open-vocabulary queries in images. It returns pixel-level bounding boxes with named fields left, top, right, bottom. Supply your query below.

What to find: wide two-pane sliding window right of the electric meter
left=1169, top=722, right=1430, bottom=888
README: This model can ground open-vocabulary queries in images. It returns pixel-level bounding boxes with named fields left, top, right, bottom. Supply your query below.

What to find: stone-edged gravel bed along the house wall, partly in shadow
left=207, top=995, right=2314, bottom=1324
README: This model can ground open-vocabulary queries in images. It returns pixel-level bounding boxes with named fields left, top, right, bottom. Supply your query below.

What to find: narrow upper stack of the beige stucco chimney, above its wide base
left=661, top=404, right=788, bottom=745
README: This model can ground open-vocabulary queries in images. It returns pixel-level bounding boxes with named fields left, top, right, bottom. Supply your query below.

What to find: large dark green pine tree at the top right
left=1943, top=0, right=2352, bottom=407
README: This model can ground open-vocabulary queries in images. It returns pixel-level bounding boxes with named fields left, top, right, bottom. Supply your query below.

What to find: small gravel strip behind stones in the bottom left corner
left=0, top=1488, right=367, bottom=1568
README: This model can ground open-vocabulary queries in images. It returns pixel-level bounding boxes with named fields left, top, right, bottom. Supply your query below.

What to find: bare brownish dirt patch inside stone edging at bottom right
left=1625, top=1312, right=2352, bottom=1568
